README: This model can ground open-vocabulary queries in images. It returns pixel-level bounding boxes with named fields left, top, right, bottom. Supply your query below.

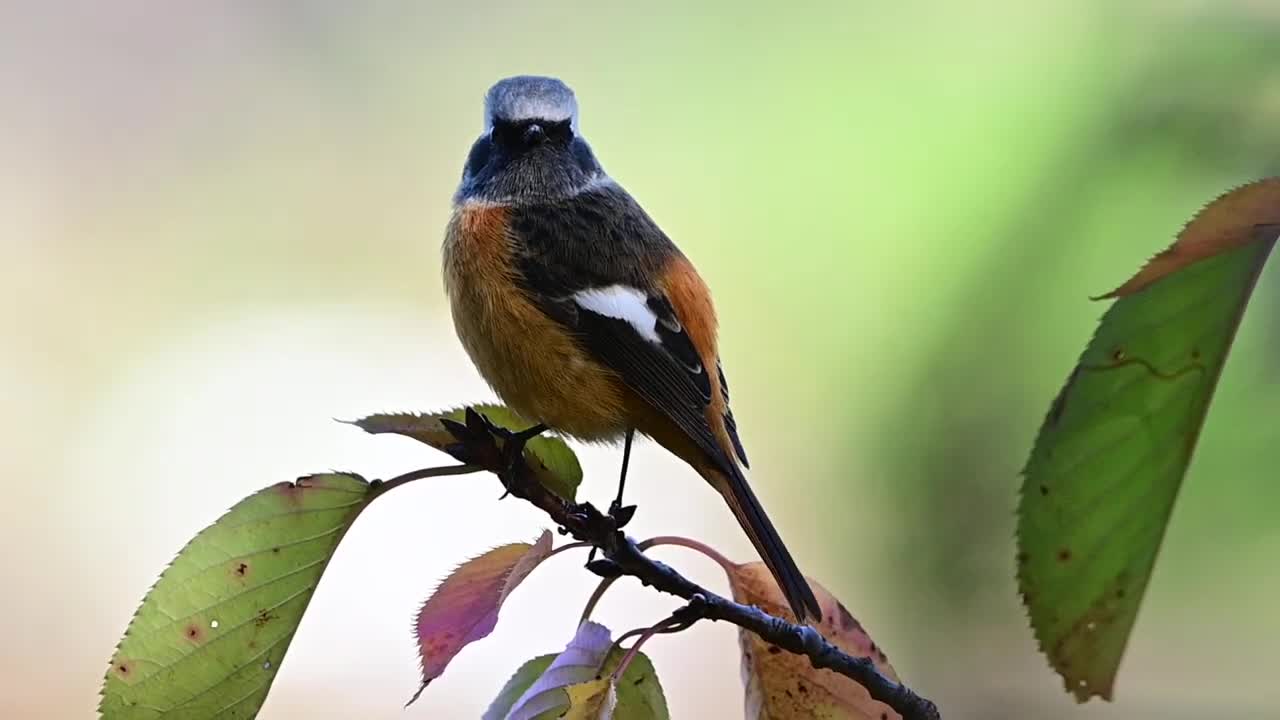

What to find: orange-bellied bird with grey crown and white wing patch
left=443, top=76, right=822, bottom=623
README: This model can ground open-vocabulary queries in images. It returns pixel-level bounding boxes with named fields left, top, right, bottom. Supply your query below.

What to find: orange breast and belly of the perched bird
left=444, top=199, right=627, bottom=439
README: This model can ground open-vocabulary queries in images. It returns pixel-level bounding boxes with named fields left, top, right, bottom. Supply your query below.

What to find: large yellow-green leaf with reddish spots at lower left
left=99, top=473, right=376, bottom=720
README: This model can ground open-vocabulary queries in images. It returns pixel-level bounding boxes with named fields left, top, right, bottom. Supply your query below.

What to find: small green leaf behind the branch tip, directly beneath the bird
left=352, top=405, right=582, bottom=501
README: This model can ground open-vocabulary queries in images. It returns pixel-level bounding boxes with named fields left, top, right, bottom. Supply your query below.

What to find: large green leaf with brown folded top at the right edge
left=1018, top=179, right=1280, bottom=702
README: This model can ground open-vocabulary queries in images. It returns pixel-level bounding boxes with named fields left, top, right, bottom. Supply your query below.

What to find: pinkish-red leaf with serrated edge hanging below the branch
left=410, top=530, right=552, bottom=703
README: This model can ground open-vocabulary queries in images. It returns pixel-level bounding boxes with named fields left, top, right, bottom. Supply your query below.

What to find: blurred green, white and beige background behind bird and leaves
left=0, top=0, right=1280, bottom=720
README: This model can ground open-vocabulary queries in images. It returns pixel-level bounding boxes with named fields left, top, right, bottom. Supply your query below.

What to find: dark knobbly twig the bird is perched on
left=399, top=409, right=941, bottom=720
